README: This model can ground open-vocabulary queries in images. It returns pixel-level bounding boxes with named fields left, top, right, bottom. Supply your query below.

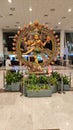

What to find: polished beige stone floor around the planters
left=0, top=67, right=73, bottom=130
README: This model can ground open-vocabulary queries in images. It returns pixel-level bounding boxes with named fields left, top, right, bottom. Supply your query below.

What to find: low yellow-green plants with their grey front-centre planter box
left=26, top=84, right=52, bottom=97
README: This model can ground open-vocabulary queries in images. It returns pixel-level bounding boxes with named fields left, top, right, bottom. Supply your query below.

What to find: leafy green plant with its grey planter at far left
left=5, top=71, right=23, bottom=91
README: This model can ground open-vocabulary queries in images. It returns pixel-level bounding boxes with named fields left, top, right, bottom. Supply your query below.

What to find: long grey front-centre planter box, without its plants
left=26, top=89, right=52, bottom=97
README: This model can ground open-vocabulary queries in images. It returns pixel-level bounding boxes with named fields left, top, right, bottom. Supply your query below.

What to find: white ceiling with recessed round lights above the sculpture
left=0, top=0, right=73, bottom=30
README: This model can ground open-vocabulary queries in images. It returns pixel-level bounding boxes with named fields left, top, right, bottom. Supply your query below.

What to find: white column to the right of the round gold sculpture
left=60, top=30, right=64, bottom=58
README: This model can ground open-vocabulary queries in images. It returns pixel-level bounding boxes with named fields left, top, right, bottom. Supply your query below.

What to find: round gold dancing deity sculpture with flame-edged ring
left=13, top=23, right=60, bottom=71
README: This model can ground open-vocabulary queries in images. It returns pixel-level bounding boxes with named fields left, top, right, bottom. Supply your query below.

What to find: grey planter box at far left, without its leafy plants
left=5, top=82, right=20, bottom=92
